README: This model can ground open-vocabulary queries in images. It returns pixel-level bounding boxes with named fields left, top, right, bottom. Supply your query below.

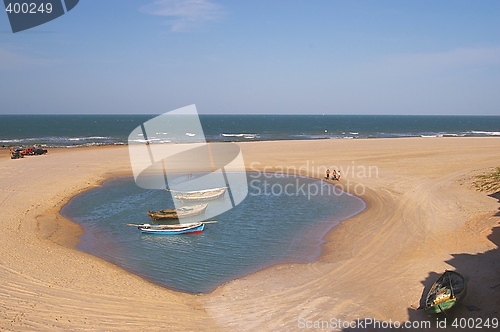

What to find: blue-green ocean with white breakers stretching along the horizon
left=0, top=114, right=500, bottom=147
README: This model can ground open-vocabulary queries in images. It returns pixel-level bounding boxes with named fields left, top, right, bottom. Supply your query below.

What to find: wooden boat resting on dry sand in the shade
left=425, top=270, right=467, bottom=313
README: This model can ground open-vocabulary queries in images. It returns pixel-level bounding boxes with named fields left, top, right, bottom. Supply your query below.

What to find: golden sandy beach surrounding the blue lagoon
left=0, top=137, right=500, bottom=331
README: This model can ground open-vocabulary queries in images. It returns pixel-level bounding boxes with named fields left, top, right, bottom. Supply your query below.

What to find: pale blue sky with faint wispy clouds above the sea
left=0, top=0, right=500, bottom=115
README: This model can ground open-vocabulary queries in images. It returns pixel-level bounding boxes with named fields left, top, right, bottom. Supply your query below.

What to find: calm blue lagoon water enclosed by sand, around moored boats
left=62, top=173, right=365, bottom=293
